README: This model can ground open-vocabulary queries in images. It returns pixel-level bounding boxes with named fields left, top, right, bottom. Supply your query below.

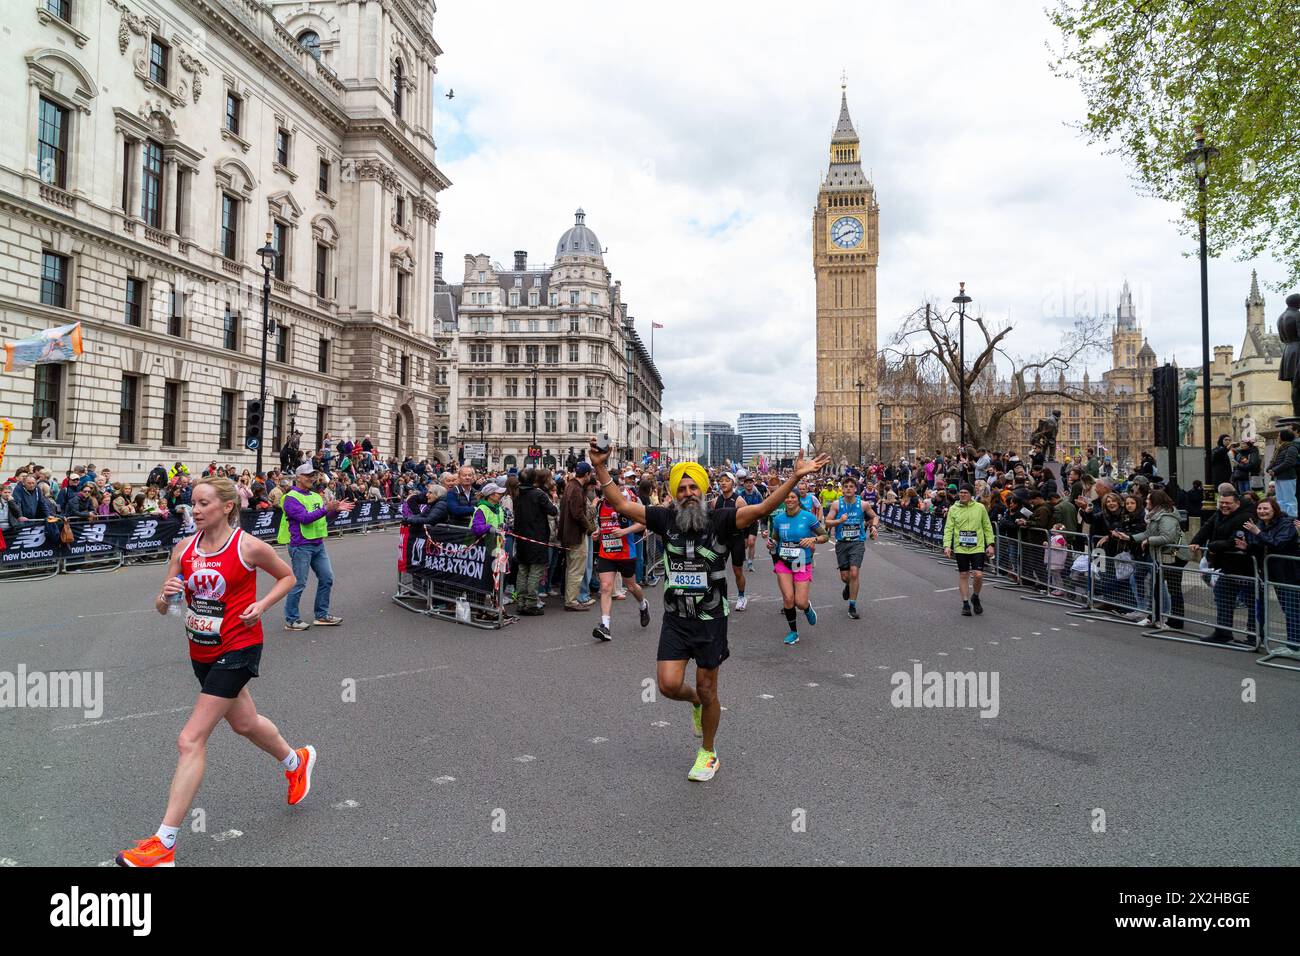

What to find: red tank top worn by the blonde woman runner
left=181, top=528, right=261, bottom=663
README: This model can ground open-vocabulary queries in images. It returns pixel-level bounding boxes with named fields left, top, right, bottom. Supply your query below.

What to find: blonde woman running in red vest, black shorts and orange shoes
left=117, top=479, right=304, bottom=866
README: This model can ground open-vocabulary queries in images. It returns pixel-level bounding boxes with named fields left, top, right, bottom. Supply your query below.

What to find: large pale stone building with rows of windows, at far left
left=0, top=0, right=450, bottom=479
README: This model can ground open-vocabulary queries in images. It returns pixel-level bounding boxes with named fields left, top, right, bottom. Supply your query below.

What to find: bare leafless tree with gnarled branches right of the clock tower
left=880, top=303, right=1106, bottom=447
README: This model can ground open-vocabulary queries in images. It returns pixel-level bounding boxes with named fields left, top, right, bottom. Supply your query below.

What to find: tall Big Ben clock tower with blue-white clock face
left=813, top=83, right=880, bottom=460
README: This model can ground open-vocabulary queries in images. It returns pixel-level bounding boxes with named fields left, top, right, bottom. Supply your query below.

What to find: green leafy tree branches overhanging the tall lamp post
left=1048, top=0, right=1300, bottom=291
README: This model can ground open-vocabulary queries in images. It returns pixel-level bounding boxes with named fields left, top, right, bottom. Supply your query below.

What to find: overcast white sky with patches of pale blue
left=434, top=0, right=1283, bottom=429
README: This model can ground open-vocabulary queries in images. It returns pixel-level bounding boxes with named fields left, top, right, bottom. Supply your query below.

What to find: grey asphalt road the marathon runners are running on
left=0, top=522, right=1300, bottom=866
